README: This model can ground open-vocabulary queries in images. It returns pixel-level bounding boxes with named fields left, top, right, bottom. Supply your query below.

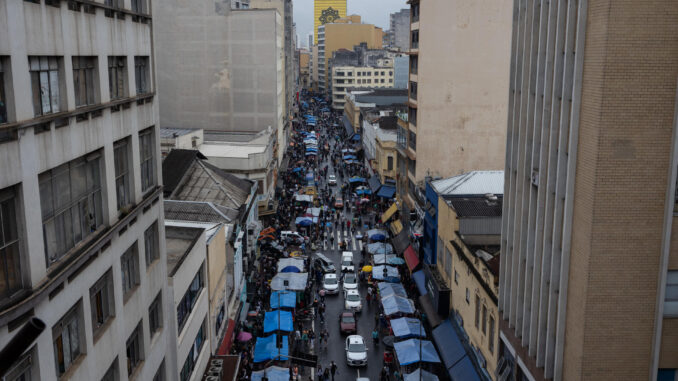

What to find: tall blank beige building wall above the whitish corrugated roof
left=410, top=0, right=513, bottom=182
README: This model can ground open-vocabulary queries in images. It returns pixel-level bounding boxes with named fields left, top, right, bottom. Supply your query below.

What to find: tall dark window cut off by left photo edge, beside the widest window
left=0, top=188, right=23, bottom=300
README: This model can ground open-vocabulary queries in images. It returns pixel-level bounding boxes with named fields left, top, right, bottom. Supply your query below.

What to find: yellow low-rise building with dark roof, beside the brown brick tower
left=437, top=195, right=502, bottom=380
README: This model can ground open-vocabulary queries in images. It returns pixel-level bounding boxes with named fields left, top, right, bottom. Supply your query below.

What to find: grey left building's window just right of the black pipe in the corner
left=52, top=302, right=82, bottom=376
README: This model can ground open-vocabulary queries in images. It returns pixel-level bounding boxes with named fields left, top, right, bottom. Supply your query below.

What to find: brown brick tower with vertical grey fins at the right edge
left=499, top=0, right=678, bottom=381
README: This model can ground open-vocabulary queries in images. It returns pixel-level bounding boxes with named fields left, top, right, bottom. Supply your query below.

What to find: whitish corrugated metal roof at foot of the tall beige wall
left=431, top=171, right=504, bottom=196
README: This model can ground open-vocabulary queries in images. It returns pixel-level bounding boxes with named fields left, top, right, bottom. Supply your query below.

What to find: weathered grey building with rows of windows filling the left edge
left=0, top=0, right=170, bottom=381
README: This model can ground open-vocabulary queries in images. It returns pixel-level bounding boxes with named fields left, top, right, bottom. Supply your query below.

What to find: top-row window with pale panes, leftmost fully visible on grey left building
left=28, top=57, right=61, bottom=116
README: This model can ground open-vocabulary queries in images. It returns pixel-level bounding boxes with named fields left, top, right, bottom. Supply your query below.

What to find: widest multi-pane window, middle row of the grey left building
left=39, top=153, right=103, bottom=265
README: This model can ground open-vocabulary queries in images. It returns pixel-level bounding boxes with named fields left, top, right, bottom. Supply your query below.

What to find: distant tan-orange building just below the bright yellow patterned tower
left=318, top=15, right=384, bottom=91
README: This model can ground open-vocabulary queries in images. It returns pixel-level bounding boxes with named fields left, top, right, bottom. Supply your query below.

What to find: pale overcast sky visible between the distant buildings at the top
left=294, top=0, right=409, bottom=47
